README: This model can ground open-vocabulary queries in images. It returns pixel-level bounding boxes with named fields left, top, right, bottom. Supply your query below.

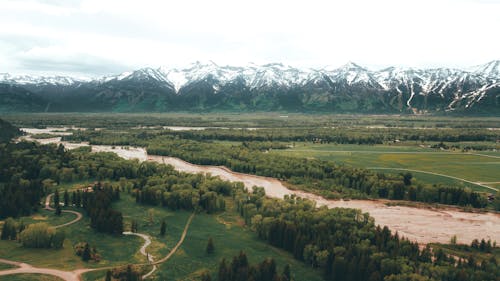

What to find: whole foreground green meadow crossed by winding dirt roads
left=0, top=190, right=322, bottom=280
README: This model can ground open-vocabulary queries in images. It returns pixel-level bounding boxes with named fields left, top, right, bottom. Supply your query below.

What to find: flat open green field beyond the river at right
left=273, top=143, right=500, bottom=192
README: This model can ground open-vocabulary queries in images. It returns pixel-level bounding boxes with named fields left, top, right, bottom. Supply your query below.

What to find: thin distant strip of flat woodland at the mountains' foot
left=9, top=112, right=498, bottom=129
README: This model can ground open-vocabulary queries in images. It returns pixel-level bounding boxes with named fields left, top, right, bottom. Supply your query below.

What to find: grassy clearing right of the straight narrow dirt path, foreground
left=157, top=199, right=322, bottom=281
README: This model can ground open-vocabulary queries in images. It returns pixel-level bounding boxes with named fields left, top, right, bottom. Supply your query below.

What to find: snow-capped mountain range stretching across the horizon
left=0, top=60, right=500, bottom=112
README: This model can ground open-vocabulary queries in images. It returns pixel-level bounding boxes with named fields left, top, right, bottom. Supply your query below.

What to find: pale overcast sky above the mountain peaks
left=0, top=0, right=500, bottom=76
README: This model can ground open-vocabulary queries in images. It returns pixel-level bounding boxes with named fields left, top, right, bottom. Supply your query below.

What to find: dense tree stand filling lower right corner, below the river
left=235, top=186, right=500, bottom=281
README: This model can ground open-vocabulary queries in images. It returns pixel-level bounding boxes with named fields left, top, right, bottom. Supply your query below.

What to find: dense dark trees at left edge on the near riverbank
left=0, top=142, right=157, bottom=218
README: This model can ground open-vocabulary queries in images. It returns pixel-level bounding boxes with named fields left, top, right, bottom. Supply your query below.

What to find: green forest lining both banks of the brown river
left=0, top=116, right=500, bottom=281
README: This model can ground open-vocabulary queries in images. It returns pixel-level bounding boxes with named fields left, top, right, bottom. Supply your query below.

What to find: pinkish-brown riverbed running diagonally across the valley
left=15, top=132, right=500, bottom=244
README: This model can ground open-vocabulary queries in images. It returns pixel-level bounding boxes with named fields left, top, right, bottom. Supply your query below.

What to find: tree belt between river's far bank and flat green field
left=60, top=130, right=488, bottom=208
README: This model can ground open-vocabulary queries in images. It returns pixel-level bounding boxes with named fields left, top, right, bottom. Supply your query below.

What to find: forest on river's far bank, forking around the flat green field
left=59, top=128, right=492, bottom=208
